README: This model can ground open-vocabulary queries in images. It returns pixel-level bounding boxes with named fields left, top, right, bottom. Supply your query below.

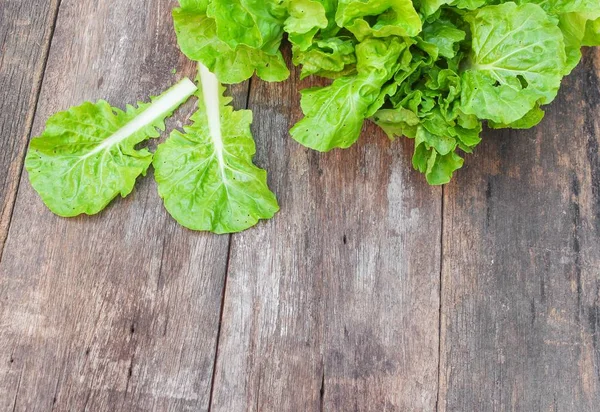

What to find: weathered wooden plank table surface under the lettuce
left=0, top=0, right=600, bottom=412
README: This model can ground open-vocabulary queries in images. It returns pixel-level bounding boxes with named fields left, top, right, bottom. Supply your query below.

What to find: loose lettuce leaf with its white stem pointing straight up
left=154, top=66, right=279, bottom=234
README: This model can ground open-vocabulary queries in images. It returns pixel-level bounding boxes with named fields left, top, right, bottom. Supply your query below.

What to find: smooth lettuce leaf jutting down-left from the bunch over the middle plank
left=290, top=37, right=407, bottom=152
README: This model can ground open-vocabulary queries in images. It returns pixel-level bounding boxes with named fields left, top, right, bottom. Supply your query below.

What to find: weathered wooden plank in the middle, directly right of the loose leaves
left=211, top=57, right=441, bottom=412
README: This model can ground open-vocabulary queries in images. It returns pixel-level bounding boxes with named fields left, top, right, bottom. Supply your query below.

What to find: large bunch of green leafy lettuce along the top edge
left=173, top=0, right=600, bottom=185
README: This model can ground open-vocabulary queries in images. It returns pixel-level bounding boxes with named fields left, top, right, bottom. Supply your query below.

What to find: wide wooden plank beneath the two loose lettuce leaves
left=0, top=0, right=239, bottom=412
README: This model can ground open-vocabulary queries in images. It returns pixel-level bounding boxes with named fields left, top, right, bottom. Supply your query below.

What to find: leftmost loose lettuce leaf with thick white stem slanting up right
left=25, top=79, right=197, bottom=217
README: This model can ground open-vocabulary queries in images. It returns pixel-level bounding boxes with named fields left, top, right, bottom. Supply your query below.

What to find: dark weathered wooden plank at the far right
left=439, top=50, right=600, bottom=412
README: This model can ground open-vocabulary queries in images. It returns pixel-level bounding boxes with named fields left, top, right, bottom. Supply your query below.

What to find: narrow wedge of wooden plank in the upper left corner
left=0, top=0, right=59, bottom=259
